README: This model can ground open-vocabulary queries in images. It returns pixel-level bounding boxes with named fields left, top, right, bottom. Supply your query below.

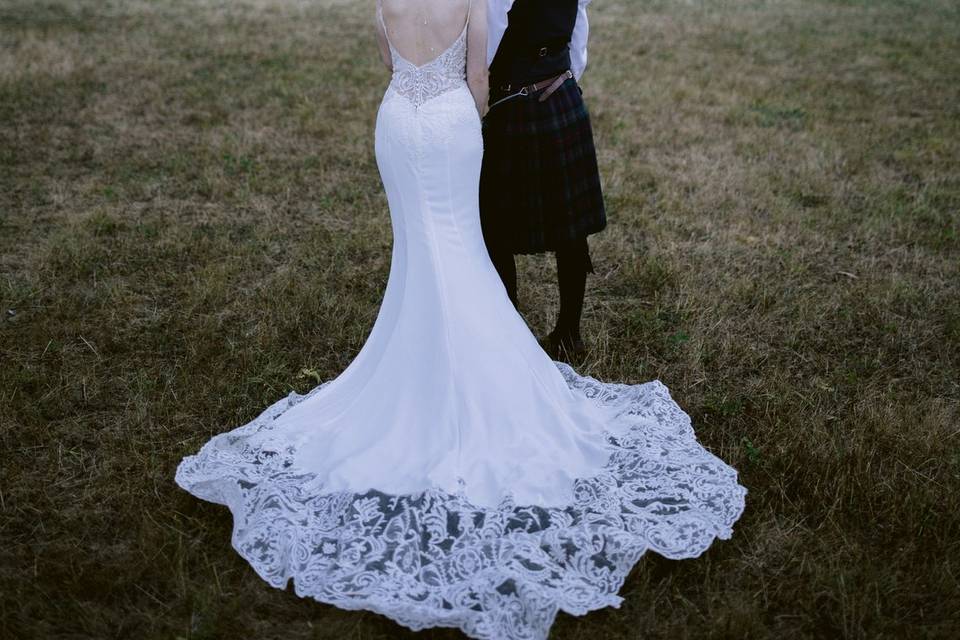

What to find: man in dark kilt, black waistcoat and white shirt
left=480, top=0, right=606, bottom=360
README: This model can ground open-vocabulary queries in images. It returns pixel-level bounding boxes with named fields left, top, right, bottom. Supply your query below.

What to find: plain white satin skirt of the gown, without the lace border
left=255, top=36, right=609, bottom=507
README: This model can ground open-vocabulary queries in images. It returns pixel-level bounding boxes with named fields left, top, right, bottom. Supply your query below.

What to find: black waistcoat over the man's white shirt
left=490, top=0, right=578, bottom=89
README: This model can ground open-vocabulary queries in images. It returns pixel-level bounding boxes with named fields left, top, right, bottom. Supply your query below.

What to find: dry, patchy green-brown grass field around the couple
left=0, top=0, right=960, bottom=640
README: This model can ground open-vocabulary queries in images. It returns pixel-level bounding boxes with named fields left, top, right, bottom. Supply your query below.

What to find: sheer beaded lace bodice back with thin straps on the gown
left=377, top=2, right=467, bottom=107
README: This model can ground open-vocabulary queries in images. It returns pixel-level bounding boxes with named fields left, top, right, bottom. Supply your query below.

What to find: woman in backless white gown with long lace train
left=176, top=0, right=746, bottom=639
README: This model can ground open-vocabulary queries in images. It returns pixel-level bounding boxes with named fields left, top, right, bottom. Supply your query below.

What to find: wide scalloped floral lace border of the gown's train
left=176, top=363, right=747, bottom=640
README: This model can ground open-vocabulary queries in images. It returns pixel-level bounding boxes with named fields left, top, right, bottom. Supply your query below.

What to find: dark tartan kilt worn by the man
left=480, top=78, right=607, bottom=253
